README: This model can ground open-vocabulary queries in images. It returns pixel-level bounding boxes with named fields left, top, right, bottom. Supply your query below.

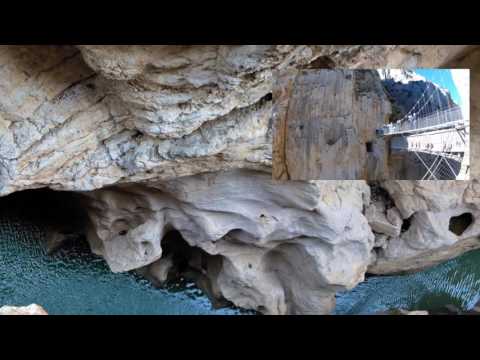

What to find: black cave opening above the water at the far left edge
left=0, top=188, right=88, bottom=253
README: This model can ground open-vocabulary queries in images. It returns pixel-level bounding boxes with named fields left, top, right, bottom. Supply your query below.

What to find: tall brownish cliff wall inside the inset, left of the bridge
left=272, top=69, right=389, bottom=180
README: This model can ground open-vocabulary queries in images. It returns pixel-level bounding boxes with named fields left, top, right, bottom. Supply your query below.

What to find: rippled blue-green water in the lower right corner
left=335, top=250, right=480, bottom=314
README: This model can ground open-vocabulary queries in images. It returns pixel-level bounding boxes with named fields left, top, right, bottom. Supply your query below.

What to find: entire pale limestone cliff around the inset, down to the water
left=0, top=45, right=480, bottom=314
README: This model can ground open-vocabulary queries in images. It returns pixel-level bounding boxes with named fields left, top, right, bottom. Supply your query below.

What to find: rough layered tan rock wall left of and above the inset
left=0, top=45, right=474, bottom=195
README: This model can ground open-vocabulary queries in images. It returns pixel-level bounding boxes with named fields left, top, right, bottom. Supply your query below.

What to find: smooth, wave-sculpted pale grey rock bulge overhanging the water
left=84, top=170, right=374, bottom=314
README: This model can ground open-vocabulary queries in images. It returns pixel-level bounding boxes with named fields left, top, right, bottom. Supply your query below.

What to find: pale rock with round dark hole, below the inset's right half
left=369, top=180, right=480, bottom=274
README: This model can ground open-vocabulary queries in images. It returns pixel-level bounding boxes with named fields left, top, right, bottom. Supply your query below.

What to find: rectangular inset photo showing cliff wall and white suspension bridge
left=272, top=69, right=470, bottom=180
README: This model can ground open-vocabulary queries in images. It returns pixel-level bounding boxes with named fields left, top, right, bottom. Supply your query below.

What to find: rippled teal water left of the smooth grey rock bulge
left=0, top=214, right=246, bottom=315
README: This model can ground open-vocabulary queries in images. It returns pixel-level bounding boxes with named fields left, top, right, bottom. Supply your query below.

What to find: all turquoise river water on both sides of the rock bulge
left=0, top=194, right=480, bottom=315
